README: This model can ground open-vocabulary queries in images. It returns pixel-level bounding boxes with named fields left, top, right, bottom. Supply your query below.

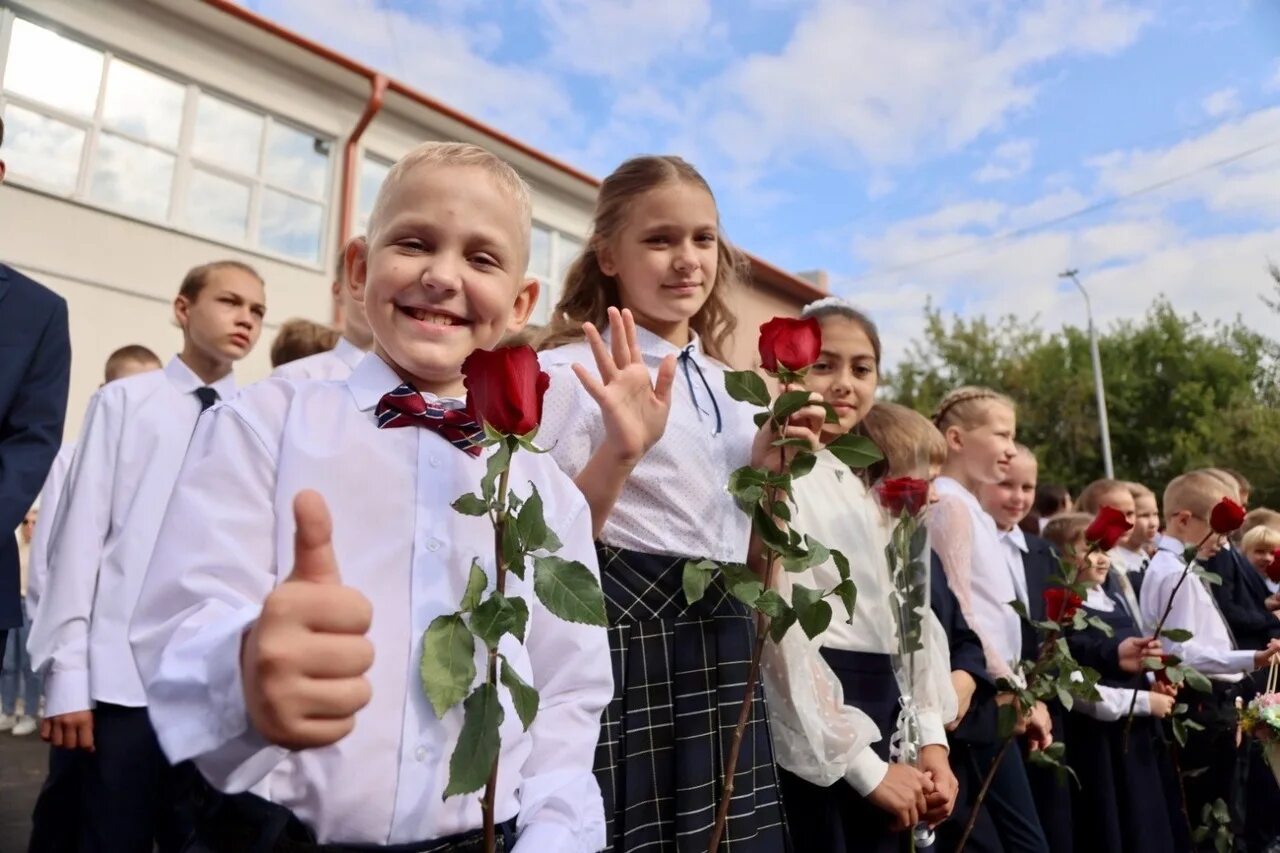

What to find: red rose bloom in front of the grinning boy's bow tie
left=462, top=346, right=552, bottom=435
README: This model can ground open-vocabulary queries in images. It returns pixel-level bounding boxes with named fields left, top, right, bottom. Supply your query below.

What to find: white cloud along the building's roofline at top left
left=240, top=0, right=580, bottom=140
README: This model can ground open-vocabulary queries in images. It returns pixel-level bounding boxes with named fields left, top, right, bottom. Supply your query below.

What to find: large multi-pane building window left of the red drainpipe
left=0, top=13, right=333, bottom=264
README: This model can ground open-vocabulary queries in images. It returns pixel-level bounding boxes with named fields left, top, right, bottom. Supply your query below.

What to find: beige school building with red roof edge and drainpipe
left=0, top=0, right=824, bottom=438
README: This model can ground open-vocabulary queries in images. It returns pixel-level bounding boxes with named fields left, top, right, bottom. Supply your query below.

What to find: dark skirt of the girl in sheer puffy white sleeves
left=778, top=648, right=906, bottom=853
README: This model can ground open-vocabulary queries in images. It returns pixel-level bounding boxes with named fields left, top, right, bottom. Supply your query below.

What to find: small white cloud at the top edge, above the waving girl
left=538, top=0, right=726, bottom=81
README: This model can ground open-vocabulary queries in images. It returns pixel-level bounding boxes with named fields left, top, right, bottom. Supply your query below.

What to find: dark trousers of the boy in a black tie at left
left=31, top=702, right=202, bottom=853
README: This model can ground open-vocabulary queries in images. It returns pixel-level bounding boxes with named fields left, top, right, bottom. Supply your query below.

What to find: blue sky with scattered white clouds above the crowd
left=246, top=0, right=1280, bottom=359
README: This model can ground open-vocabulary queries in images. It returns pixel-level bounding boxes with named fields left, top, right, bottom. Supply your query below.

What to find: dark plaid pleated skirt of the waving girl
left=595, top=546, right=790, bottom=853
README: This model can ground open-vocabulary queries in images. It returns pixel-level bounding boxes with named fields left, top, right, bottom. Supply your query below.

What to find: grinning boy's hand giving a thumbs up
left=241, top=491, right=374, bottom=749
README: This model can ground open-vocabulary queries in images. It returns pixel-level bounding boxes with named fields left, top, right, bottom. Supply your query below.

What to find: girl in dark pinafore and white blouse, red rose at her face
left=1044, top=512, right=1188, bottom=853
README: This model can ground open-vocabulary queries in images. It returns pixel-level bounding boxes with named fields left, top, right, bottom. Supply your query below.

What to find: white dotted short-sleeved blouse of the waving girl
left=538, top=328, right=758, bottom=562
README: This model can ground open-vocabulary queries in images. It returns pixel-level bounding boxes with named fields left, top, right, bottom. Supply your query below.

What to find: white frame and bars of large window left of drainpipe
left=0, top=8, right=339, bottom=270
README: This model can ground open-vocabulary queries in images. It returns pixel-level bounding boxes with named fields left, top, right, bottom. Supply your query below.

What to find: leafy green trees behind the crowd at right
left=886, top=297, right=1280, bottom=507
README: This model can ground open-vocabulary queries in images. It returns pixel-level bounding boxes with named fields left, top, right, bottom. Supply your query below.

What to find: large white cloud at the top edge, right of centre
left=710, top=0, right=1151, bottom=165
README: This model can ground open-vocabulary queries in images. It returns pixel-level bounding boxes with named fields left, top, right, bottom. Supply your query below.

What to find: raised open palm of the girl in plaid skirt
left=573, top=307, right=676, bottom=465
